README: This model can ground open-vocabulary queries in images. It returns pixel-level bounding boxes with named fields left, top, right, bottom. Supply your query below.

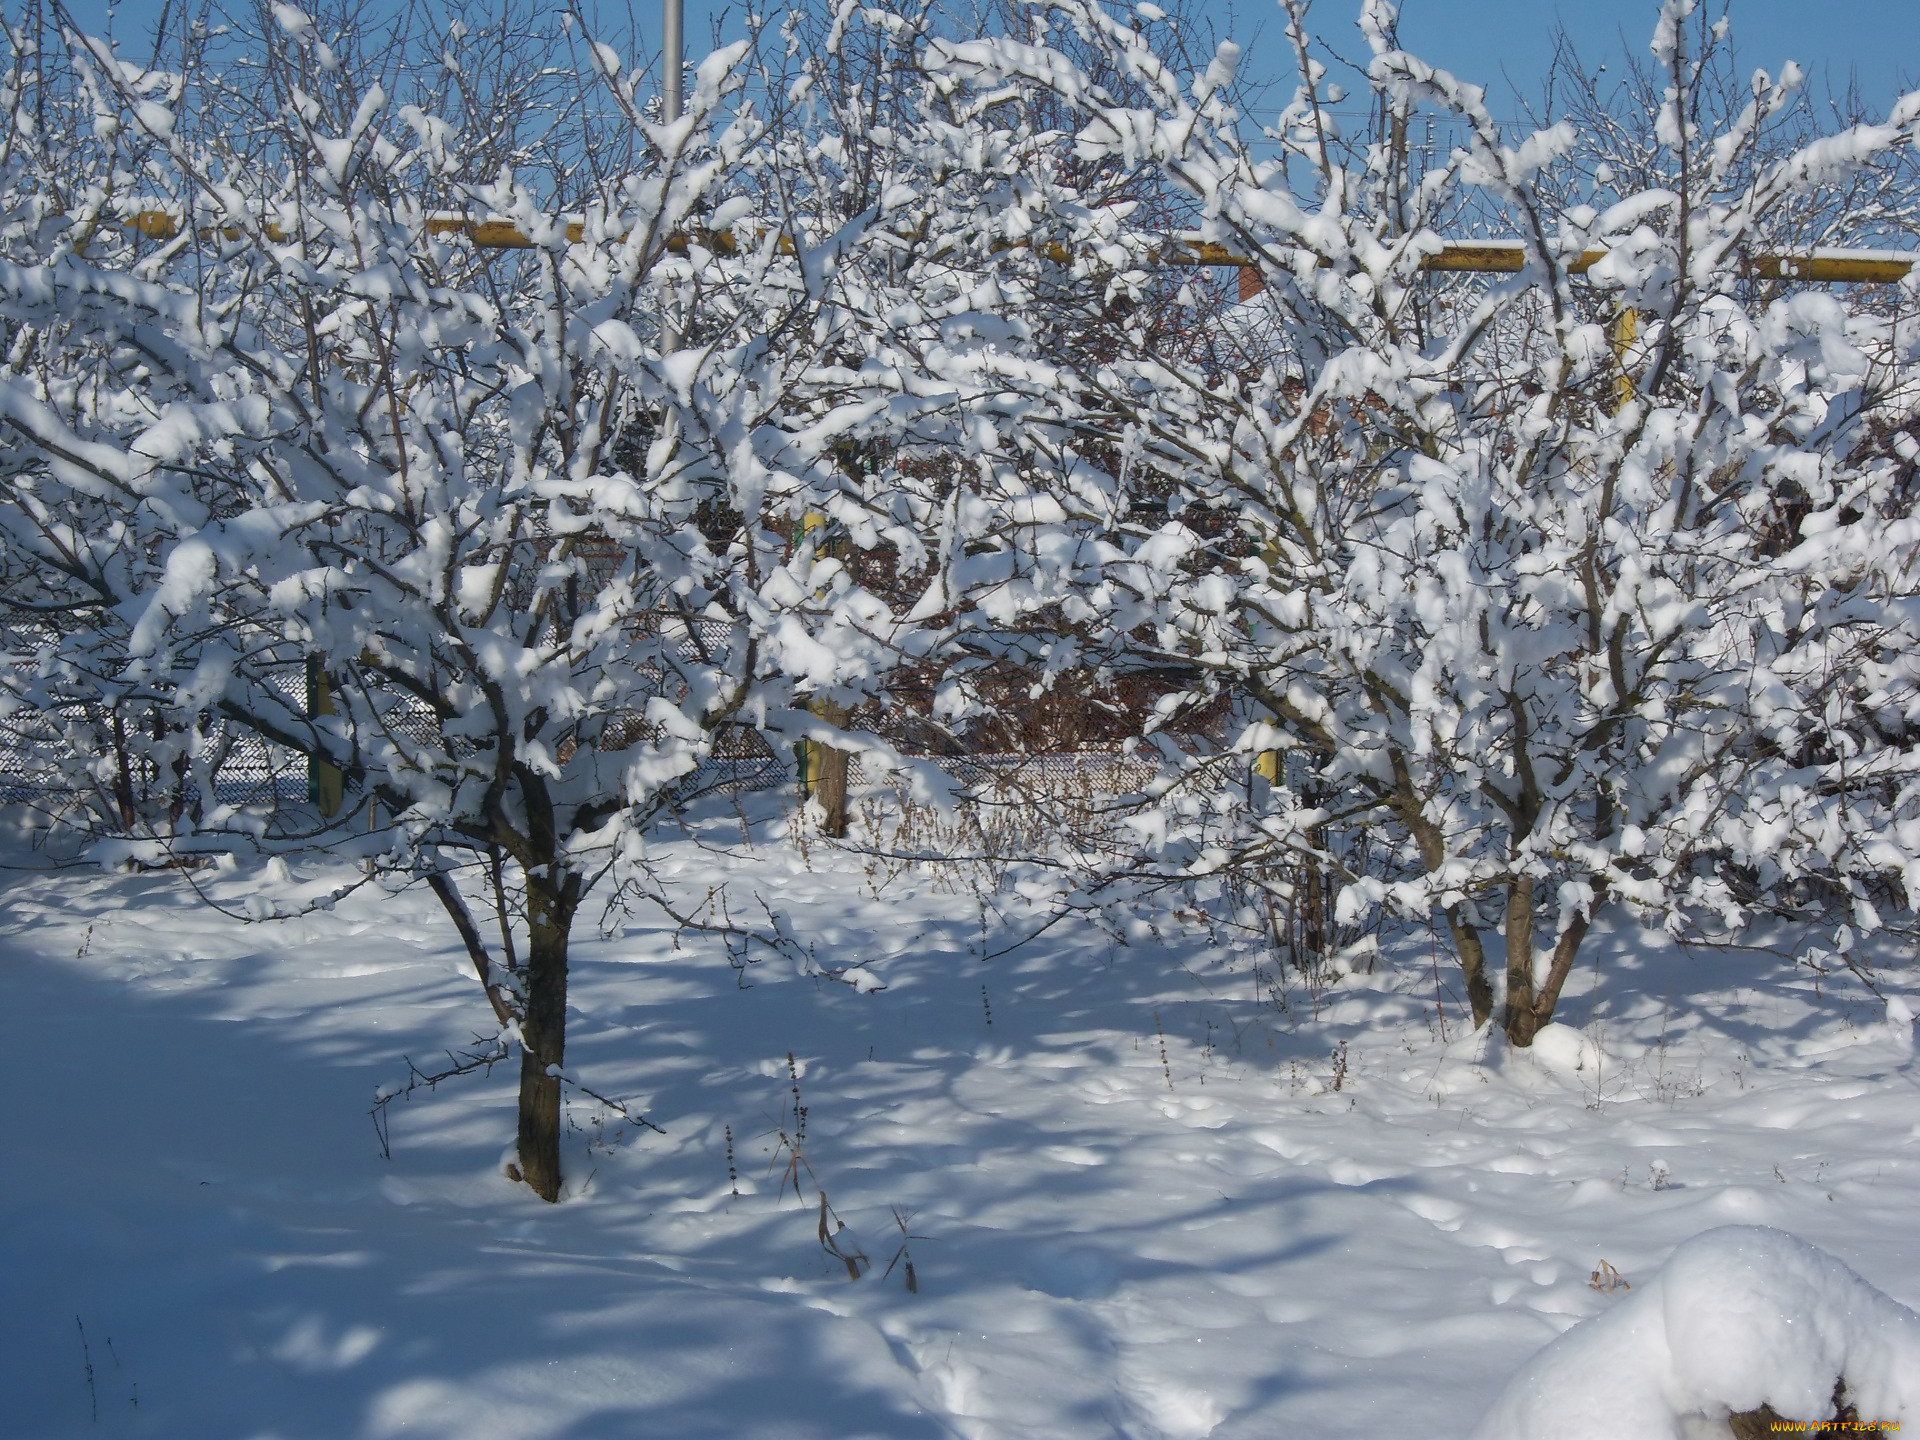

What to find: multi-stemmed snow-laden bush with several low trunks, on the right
left=933, top=0, right=1920, bottom=1044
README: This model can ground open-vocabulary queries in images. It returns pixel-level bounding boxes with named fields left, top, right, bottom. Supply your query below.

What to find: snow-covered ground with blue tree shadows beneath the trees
left=0, top=818, right=1920, bottom=1440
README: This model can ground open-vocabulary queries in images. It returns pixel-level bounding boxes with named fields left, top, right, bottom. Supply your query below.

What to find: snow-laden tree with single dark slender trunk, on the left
left=0, top=4, right=1029, bottom=1200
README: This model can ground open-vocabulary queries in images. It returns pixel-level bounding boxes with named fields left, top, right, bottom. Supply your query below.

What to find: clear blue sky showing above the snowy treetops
left=56, top=0, right=1920, bottom=115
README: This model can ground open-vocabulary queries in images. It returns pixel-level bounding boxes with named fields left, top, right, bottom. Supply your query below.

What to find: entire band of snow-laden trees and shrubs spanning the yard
left=0, top=0, right=1920, bottom=1196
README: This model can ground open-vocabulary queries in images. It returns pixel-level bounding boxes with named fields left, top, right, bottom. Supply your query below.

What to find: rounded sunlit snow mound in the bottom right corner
left=1475, top=1225, right=1920, bottom=1440
